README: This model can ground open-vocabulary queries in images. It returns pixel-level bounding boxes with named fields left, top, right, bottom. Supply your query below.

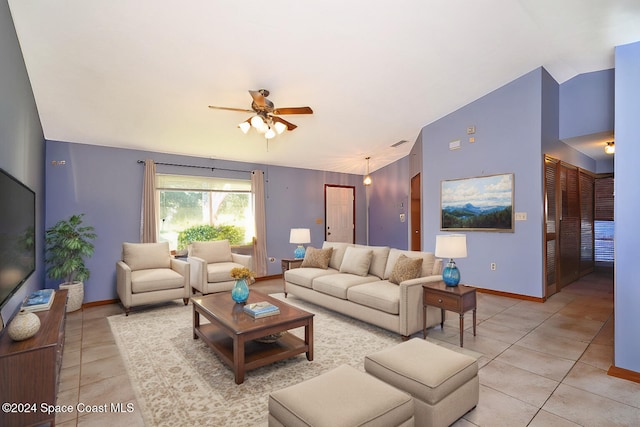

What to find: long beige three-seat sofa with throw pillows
left=284, top=242, right=442, bottom=339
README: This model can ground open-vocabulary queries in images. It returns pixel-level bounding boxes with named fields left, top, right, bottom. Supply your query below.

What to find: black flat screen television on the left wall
left=0, top=169, right=36, bottom=308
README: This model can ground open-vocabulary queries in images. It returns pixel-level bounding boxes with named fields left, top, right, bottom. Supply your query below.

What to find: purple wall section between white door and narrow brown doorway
left=368, top=156, right=411, bottom=249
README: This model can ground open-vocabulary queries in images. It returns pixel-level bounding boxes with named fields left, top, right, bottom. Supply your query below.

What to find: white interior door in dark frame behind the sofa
left=324, top=185, right=356, bottom=243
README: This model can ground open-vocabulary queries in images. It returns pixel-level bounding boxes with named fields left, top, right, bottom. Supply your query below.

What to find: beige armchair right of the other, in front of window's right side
left=187, top=240, right=252, bottom=295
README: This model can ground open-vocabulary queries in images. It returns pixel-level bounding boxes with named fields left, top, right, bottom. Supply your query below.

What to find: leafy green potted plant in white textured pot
left=45, top=214, right=96, bottom=311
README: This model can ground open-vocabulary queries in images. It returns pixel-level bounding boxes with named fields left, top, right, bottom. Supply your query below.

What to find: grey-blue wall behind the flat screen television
left=0, top=1, right=44, bottom=323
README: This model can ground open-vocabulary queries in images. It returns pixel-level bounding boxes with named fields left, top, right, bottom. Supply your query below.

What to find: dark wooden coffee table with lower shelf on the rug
left=191, top=290, right=314, bottom=384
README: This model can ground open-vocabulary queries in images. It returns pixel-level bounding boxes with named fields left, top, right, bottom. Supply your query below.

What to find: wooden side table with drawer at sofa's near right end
left=422, top=282, right=476, bottom=347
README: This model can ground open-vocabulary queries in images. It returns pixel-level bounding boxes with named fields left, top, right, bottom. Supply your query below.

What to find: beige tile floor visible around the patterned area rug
left=56, top=273, right=640, bottom=427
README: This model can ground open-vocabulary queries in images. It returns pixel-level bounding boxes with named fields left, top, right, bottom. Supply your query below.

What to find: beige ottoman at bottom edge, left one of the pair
left=269, top=365, right=414, bottom=427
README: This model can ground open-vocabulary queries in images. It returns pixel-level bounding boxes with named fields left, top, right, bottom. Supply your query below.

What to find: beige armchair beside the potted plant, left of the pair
left=116, top=242, right=190, bottom=316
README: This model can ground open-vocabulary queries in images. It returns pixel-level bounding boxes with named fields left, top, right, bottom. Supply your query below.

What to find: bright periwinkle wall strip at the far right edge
left=614, top=42, right=640, bottom=372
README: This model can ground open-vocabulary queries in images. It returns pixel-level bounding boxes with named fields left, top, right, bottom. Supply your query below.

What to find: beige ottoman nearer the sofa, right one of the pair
left=364, top=338, right=480, bottom=427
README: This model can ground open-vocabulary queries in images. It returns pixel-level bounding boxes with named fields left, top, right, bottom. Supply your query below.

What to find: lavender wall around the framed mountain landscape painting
left=421, top=69, right=543, bottom=297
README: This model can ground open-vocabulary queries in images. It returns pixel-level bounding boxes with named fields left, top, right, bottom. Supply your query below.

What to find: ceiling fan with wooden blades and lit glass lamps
left=209, top=89, right=313, bottom=139
